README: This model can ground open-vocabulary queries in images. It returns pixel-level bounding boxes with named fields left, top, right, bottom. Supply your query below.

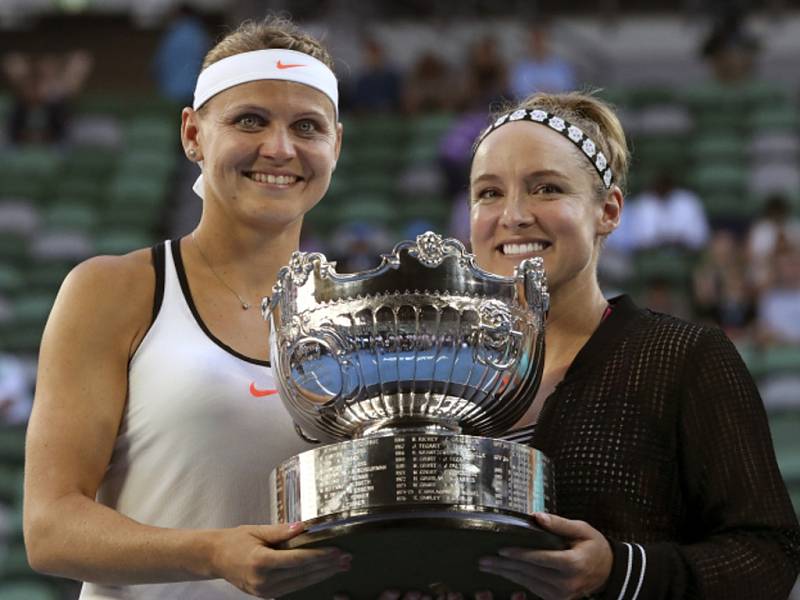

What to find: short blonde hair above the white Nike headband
left=203, top=15, right=333, bottom=71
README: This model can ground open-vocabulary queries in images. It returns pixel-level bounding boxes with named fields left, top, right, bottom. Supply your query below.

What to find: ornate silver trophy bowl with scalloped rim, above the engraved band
left=262, top=231, right=549, bottom=441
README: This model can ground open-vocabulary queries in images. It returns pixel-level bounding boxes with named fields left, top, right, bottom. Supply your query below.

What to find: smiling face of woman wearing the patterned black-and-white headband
left=470, top=122, right=622, bottom=293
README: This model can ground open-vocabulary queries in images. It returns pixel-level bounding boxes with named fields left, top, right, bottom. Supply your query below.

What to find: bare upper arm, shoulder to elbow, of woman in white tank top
left=25, top=249, right=162, bottom=512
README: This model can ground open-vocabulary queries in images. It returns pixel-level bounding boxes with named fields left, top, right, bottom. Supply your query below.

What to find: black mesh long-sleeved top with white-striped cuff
left=516, top=296, right=800, bottom=600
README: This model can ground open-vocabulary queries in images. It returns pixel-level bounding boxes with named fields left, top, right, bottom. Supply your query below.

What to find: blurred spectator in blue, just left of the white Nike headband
left=153, top=3, right=211, bottom=106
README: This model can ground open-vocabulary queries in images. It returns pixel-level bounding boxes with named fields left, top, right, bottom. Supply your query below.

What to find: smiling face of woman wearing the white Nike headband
left=181, top=81, right=341, bottom=227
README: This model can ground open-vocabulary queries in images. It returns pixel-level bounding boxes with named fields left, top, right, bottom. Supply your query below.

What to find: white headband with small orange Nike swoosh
left=192, top=48, right=339, bottom=198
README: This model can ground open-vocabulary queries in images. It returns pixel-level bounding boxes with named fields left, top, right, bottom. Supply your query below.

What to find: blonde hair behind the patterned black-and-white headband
left=478, top=92, right=630, bottom=192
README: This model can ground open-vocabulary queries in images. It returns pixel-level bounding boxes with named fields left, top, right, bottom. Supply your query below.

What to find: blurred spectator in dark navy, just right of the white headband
left=352, top=38, right=402, bottom=112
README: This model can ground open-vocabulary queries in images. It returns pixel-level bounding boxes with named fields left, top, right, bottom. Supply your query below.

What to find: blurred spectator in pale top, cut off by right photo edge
left=758, top=247, right=800, bottom=345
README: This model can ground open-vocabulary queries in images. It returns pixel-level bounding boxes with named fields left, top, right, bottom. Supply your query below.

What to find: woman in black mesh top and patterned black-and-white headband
left=470, top=93, right=800, bottom=600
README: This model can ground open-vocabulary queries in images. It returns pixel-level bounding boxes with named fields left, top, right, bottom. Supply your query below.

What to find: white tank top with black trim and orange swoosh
left=80, top=241, right=311, bottom=600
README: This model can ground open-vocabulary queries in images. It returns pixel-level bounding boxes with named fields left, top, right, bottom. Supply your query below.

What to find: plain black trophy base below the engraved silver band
left=281, top=510, right=567, bottom=600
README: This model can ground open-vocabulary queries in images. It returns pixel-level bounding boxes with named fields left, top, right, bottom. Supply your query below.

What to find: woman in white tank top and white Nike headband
left=24, top=18, right=350, bottom=600
